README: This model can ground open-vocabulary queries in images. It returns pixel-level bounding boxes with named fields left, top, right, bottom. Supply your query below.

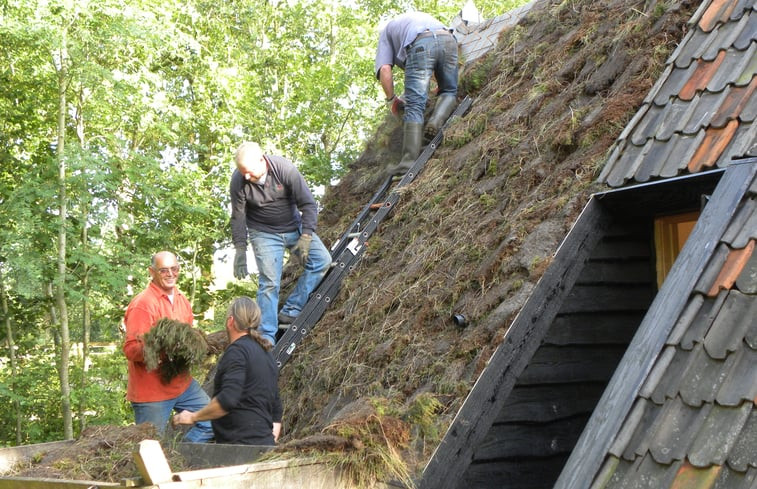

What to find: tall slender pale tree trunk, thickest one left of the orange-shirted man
left=55, top=26, right=74, bottom=440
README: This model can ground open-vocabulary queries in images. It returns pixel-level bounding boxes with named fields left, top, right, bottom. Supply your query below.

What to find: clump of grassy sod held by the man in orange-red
left=144, top=318, right=208, bottom=384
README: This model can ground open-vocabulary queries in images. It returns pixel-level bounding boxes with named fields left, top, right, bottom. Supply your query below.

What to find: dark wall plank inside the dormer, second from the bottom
left=474, top=413, right=591, bottom=463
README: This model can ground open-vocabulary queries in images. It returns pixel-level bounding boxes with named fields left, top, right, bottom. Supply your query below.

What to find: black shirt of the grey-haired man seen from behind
left=212, top=336, right=283, bottom=445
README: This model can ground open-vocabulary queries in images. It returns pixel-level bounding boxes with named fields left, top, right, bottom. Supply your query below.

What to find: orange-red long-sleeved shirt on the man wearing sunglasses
left=123, top=282, right=194, bottom=402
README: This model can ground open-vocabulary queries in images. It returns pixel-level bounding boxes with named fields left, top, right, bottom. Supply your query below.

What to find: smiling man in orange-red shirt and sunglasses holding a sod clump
left=123, top=251, right=213, bottom=443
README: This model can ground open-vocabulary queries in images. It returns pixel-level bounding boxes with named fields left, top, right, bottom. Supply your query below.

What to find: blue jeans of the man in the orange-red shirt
left=131, top=379, right=213, bottom=443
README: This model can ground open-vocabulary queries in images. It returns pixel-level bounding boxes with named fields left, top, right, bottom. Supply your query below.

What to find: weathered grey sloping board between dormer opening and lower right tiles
left=554, top=161, right=757, bottom=489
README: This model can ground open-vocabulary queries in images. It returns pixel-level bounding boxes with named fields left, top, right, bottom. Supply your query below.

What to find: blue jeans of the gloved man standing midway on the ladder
left=249, top=229, right=331, bottom=345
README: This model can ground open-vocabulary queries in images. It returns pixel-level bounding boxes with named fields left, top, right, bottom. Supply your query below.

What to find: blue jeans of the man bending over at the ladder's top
left=403, top=35, right=457, bottom=124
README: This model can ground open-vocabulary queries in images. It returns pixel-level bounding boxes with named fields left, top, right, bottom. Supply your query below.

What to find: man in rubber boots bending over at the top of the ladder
left=374, top=12, right=457, bottom=175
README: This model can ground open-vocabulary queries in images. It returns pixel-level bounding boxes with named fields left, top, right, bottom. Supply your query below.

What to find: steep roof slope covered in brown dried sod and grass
left=281, top=0, right=694, bottom=480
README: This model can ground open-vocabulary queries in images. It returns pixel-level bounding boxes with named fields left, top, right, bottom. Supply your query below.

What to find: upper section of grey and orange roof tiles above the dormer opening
left=599, top=0, right=757, bottom=187
